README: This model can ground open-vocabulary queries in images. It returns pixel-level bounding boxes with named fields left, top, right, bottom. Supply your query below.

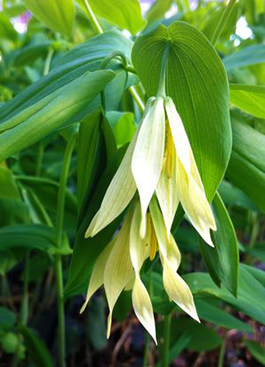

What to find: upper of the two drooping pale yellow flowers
left=86, top=97, right=216, bottom=246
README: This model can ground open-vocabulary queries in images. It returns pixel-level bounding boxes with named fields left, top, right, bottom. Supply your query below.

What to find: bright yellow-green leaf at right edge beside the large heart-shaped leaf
left=230, top=84, right=265, bottom=119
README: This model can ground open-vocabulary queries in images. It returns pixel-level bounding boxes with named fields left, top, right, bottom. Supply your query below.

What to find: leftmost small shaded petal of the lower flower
left=80, top=240, right=114, bottom=313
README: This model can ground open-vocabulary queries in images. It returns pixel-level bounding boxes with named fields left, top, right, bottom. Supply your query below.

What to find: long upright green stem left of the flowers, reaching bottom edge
left=54, top=138, right=75, bottom=367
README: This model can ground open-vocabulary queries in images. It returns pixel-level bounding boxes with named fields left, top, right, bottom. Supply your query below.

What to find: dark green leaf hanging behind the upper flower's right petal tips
left=199, top=194, right=239, bottom=296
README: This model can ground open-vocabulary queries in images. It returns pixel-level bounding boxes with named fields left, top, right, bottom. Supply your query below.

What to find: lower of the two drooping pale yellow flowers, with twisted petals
left=81, top=198, right=199, bottom=342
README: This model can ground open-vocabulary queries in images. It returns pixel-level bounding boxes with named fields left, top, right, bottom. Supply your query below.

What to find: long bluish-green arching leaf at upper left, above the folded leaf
left=0, top=30, right=132, bottom=123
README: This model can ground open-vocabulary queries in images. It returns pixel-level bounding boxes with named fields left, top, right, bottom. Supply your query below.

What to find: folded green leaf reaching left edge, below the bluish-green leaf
left=0, top=71, right=115, bottom=161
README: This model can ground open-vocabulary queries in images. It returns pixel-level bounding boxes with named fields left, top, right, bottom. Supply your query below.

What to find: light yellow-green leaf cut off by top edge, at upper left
left=23, top=0, right=75, bottom=36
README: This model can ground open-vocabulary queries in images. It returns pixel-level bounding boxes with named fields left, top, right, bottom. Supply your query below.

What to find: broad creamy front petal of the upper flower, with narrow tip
left=132, top=98, right=165, bottom=237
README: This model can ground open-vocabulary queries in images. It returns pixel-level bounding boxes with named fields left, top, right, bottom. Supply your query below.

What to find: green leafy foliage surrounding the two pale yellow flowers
left=0, top=0, right=265, bottom=367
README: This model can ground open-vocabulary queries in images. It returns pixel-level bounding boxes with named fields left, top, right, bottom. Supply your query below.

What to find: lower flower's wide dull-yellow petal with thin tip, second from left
left=104, top=209, right=134, bottom=336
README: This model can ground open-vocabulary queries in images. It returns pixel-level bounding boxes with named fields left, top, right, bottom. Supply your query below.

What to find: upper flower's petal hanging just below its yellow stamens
left=156, top=156, right=179, bottom=237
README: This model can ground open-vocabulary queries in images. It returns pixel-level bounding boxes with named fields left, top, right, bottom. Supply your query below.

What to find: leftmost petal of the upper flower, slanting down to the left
left=85, top=133, right=137, bottom=238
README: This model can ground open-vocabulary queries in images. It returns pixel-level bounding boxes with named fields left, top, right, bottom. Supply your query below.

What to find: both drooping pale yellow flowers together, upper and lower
left=81, top=89, right=216, bottom=341
